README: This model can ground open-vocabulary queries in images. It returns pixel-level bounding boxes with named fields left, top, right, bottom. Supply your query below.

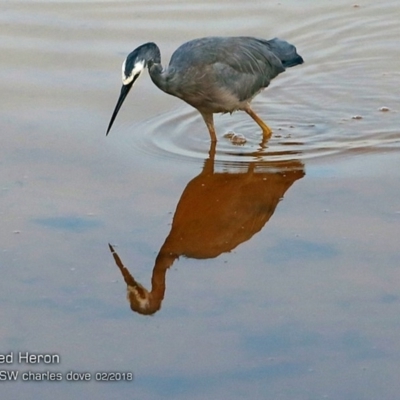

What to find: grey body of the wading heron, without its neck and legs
left=165, top=37, right=298, bottom=106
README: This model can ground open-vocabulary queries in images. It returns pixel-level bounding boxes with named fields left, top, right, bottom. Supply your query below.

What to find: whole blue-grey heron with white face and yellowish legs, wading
left=107, top=37, right=303, bottom=141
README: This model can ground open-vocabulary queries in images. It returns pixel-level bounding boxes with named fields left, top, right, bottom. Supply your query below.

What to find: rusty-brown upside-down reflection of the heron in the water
left=109, top=144, right=305, bottom=315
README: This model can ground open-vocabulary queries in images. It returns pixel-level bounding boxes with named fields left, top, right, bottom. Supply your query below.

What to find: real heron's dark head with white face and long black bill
left=107, top=43, right=160, bottom=135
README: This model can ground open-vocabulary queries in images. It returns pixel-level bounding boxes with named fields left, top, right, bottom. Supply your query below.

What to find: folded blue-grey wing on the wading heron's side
left=170, top=37, right=285, bottom=101
